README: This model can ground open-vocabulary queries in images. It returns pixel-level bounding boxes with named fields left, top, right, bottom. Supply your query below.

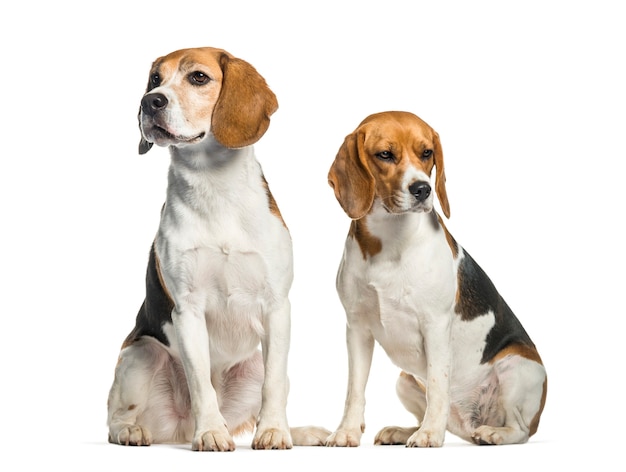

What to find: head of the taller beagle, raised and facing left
left=138, top=48, right=278, bottom=154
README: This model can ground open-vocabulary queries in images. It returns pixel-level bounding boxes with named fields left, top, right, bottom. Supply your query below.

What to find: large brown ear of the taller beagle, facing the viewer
left=211, top=54, right=278, bottom=148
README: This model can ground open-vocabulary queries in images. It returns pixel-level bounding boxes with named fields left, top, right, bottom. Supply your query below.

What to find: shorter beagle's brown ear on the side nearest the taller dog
left=328, top=132, right=375, bottom=220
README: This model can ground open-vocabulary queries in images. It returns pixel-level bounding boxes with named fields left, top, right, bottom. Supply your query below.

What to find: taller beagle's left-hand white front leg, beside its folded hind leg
left=172, top=306, right=235, bottom=451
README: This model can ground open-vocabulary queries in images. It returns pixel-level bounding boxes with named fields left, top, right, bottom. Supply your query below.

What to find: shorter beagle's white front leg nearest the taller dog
left=326, top=323, right=374, bottom=447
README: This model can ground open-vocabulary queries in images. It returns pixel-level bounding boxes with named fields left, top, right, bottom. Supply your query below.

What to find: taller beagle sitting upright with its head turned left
left=107, top=48, right=329, bottom=451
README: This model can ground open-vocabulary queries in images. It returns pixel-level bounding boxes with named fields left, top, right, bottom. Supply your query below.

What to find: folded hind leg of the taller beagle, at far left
left=107, top=337, right=189, bottom=446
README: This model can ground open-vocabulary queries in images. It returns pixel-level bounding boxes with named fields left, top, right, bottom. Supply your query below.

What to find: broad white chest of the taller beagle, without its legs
left=156, top=151, right=293, bottom=359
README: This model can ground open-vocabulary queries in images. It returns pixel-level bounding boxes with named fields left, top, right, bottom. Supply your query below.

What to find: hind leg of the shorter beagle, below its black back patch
left=472, top=356, right=547, bottom=444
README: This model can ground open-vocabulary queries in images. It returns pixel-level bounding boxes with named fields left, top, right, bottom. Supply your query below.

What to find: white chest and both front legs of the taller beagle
left=156, top=147, right=293, bottom=448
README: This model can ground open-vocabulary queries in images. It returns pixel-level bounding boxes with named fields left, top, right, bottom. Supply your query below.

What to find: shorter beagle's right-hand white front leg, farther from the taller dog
left=406, top=316, right=452, bottom=447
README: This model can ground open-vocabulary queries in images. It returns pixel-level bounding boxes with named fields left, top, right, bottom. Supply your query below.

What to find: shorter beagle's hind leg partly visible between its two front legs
left=374, top=372, right=426, bottom=445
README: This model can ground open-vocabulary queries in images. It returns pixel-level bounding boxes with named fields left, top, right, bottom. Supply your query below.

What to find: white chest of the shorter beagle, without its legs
left=338, top=211, right=456, bottom=375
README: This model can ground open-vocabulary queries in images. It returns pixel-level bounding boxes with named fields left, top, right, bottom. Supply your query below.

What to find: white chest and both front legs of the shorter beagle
left=330, top=202, right=456, bottom=445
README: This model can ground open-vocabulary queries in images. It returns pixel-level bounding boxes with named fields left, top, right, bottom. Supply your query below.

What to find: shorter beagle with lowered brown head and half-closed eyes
left=326, top=111, right=547, bottom=447
